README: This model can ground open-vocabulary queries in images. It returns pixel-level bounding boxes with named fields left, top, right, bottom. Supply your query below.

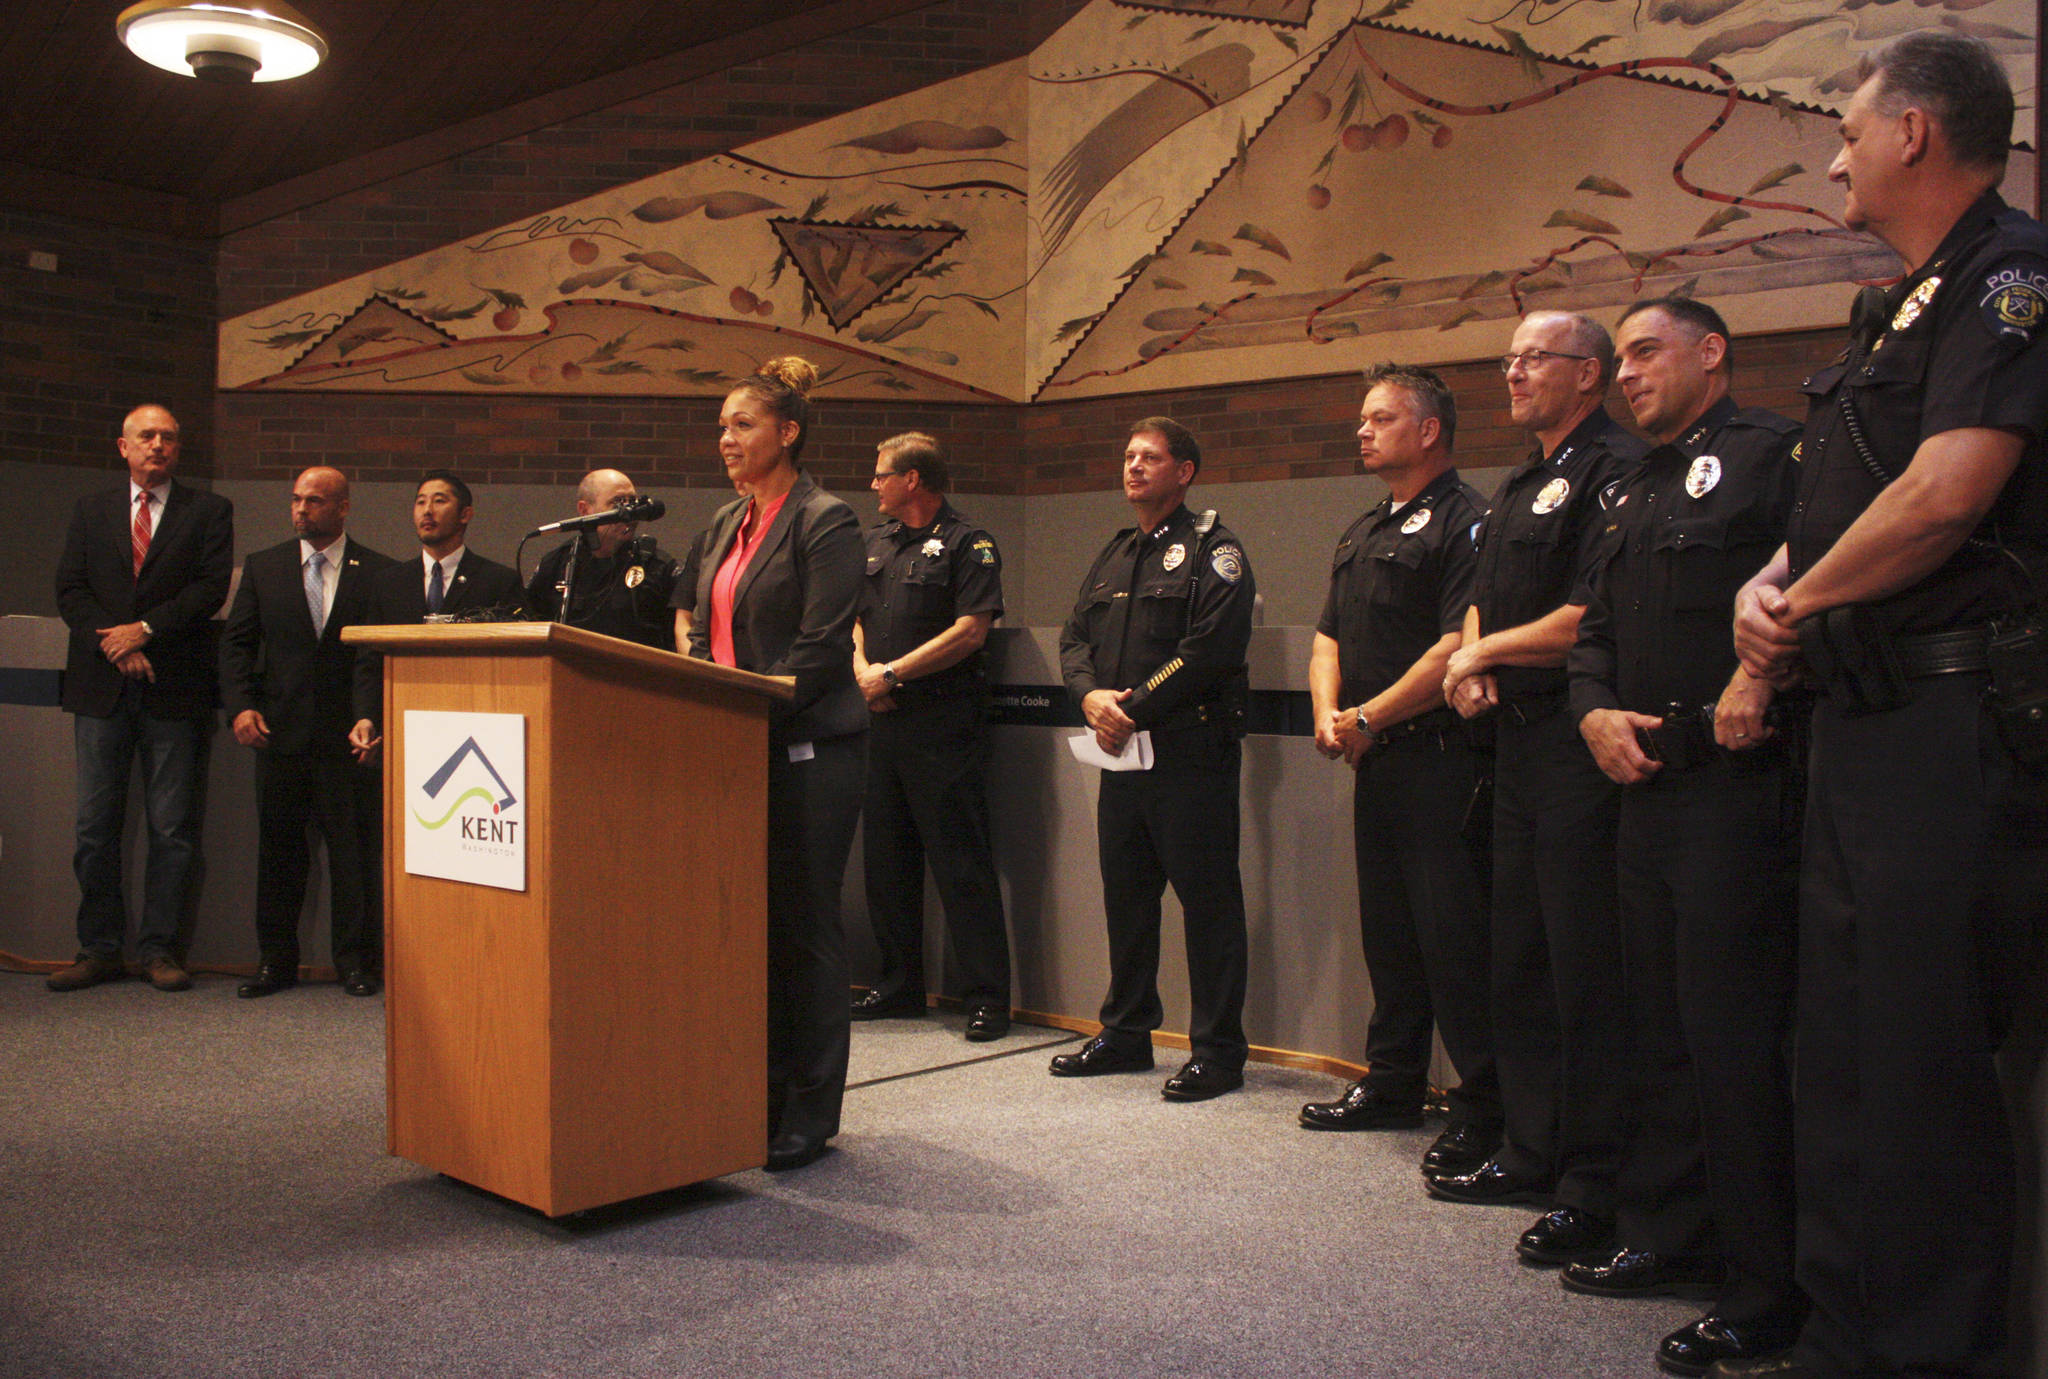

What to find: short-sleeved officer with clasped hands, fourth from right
left=1300, top=365, right=1501, bottom=1172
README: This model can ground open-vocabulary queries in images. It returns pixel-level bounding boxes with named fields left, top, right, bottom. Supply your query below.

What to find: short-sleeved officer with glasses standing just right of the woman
left=852, top=432, right=1010, bottom=1043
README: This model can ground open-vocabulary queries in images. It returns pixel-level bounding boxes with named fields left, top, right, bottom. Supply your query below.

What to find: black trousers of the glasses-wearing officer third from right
left=1493, top=705, right=1628, bottom=1217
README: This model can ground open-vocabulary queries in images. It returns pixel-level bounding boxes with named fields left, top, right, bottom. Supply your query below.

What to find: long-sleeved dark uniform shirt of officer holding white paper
left=1059, top=506, right=1255, bottom=727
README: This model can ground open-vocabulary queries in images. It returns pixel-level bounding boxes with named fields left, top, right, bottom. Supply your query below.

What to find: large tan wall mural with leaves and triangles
left=219, top=0, right=2038, bottom=402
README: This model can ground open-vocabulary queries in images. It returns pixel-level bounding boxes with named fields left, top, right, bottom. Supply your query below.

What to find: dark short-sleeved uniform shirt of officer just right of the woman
left=860, top=502, right=1004, bottom=697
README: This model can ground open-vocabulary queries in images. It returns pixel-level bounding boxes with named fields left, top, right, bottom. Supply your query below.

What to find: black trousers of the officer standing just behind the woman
left=860, top=695, right=1010, bottom=1010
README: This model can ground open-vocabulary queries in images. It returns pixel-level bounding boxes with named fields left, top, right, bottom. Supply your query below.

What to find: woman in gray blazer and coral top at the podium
left=674, top=357, right=868, bottom=1170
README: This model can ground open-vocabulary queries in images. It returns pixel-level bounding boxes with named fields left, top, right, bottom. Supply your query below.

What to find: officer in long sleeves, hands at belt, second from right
left=1563, top=297, right=1804, bottom=1375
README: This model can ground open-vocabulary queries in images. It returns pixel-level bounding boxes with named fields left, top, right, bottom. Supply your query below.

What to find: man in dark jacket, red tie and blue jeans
left=49, top=404, right=236, bottom=992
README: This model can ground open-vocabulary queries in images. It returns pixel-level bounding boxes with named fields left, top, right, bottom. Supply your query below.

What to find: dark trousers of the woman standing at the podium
left=768, top=734, right=866, bottom=1139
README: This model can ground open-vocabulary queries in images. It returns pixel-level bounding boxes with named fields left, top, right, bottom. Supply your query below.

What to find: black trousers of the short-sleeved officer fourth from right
left=1352, top=732, right=1501, bottom=1127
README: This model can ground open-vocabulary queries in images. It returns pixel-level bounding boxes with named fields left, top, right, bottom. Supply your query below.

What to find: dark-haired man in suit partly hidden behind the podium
left=348, top=469, right=524, bottom=760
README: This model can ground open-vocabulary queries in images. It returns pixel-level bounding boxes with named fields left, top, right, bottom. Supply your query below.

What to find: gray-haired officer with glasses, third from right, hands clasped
left=1425, top=311, right=1645, bottom=1264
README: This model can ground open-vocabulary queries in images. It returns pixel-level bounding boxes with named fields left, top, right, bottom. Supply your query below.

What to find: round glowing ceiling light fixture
left=115, top=0, right=328, bottom=86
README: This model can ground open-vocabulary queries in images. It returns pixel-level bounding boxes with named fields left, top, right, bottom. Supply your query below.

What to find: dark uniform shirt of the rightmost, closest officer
left=1788, top=193, right=2048, bottom=633
